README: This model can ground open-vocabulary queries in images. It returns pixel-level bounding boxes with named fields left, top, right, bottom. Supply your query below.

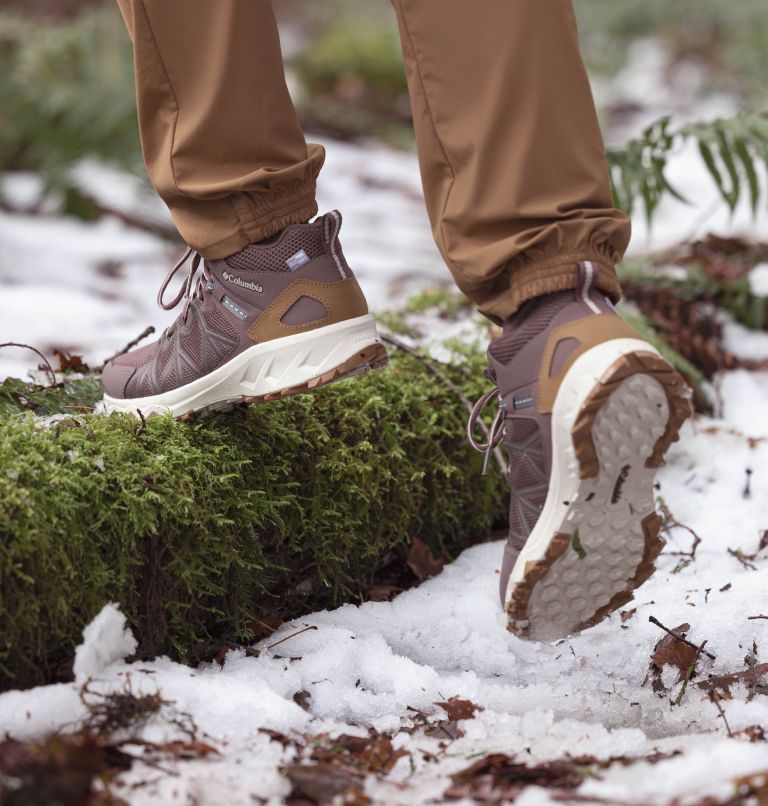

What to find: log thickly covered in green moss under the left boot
left=0, top=344, right=504, bottom=687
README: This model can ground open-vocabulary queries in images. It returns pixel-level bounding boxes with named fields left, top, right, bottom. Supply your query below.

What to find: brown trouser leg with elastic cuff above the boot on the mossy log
left=118, top=0, right=324, bottom=259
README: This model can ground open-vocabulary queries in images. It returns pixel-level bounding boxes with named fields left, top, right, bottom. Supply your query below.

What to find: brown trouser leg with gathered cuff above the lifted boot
left=393, top=0, right=630, bottom=320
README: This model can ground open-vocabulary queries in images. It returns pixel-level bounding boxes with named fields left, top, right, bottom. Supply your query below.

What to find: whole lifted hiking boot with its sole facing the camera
left=469, top=263, right=691, bottom=641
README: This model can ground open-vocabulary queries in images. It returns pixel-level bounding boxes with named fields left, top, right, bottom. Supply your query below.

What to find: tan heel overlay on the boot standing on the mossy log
left=248, top=277, right=368, bottom=342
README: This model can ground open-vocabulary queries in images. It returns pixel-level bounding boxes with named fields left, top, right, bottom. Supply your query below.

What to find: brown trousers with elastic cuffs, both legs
left=118, top=0, right=630, bottom=321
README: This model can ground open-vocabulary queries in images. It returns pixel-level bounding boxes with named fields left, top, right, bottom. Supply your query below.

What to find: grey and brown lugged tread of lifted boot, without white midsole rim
left=506, top=352, right=691, bottom=640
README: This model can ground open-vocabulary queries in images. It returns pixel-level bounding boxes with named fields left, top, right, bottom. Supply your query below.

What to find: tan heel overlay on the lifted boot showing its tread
left=536, top=316, right=641, bottom=414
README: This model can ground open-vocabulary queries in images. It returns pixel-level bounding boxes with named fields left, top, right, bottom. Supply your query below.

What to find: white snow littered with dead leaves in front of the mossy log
left=0, top=400, right=768, bottom=806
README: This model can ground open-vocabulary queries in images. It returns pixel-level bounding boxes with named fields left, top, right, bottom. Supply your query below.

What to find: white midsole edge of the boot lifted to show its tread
left=506, top=339, right=659, bottom=602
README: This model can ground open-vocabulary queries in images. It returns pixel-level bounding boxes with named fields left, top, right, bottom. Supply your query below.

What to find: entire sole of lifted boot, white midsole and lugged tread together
left=506, top=339, right=687, bottom=641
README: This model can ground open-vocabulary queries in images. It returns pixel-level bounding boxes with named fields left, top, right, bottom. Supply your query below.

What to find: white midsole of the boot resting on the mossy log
left=104, top=314, right=381, bottom=417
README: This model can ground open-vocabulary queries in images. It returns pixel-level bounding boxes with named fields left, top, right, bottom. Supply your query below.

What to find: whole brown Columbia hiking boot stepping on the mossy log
left=102, top=210, right=387, bottom=418
